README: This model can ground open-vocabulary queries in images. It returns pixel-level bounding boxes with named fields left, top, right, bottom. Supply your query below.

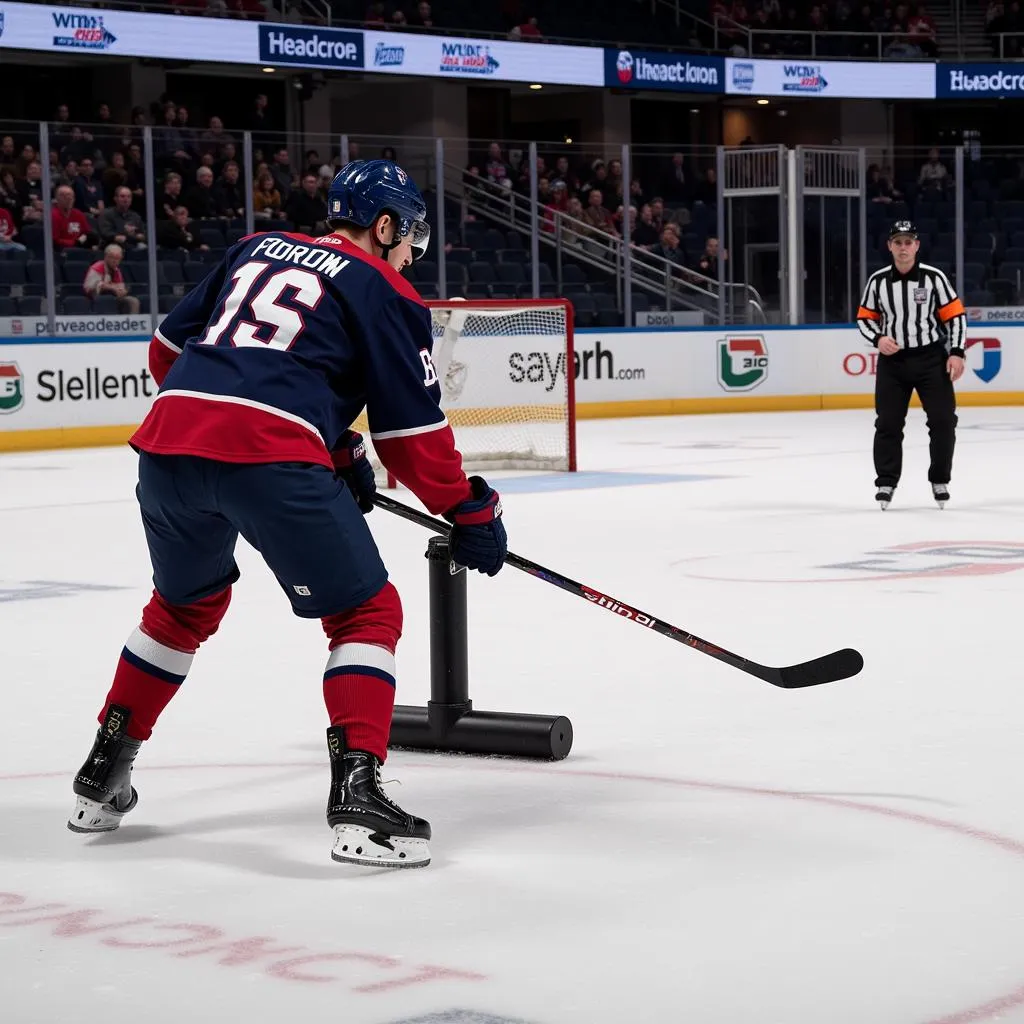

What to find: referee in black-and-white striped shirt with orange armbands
left=857, top=220, right=967, bottom=509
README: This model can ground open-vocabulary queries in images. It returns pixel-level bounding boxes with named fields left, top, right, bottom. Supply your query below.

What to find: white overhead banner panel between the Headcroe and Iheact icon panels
left=364, top=32, right=604, bottom=86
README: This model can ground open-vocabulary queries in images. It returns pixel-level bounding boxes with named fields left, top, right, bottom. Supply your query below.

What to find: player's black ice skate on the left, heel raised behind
left=68, top=705, right=142, bottom=833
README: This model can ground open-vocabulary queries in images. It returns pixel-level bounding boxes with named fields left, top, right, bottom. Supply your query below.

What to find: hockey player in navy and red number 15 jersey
left=68, top=160, right=507, bottom=867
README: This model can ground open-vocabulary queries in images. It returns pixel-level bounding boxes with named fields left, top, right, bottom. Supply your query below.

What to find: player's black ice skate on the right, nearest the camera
left=327, top=726, right=430, bottom=867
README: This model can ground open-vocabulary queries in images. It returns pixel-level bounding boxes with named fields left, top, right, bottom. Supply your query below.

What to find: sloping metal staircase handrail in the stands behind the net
left=445, top=165, right=767, bottom=323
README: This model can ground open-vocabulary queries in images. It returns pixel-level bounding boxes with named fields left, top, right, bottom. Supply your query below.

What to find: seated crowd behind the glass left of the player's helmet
left=0, top=94, right=340, bottom=315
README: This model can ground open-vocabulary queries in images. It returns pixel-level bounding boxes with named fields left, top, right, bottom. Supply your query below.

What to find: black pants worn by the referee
left=874, top=344, right=956, bottom=487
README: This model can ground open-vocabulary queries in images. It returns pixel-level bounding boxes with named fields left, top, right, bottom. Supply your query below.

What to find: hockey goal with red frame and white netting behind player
left=362, top=299, right=575, bottom=483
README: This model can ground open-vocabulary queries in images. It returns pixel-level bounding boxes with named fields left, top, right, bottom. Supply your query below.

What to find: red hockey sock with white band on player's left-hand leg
left=99, top=587, right=231, bottom=739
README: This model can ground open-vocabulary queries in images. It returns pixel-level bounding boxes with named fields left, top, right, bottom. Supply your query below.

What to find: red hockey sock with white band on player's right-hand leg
left=324, top=583, right=401, bottom=761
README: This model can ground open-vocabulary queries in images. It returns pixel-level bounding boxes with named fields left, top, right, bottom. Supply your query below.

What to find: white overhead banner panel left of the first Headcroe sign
left=0, top=2, right=262, bottom=65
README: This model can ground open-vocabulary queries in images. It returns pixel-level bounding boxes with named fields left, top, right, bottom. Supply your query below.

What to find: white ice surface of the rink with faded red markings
left=0, top=409, right=1024, bottom=1024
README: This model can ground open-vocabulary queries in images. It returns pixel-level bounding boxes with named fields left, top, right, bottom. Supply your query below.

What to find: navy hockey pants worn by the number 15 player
left=135, top=452, right=387, bottom=618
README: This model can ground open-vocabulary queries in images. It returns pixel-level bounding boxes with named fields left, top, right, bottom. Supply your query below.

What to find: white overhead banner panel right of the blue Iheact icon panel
left=725, top=57, right=935, bottom=99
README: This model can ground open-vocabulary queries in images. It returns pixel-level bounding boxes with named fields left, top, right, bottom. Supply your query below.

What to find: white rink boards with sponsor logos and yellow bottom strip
left=0, top=324, right=1024, bottom=451
